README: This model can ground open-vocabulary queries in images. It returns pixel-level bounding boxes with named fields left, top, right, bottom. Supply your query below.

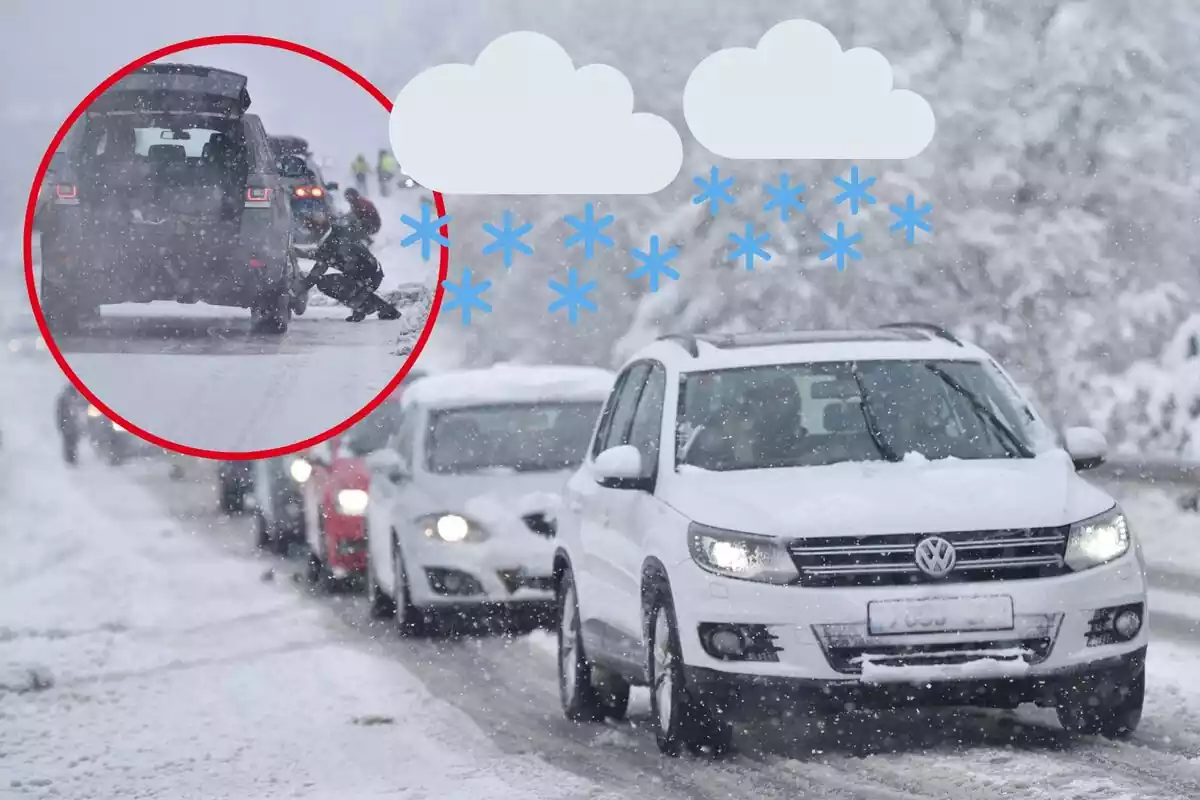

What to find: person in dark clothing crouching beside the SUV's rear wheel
left=305, top=188, right=400, bottom=323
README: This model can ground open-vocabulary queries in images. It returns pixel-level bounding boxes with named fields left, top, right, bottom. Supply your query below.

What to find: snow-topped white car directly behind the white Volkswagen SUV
left=365, top=366, right=613, bottom=633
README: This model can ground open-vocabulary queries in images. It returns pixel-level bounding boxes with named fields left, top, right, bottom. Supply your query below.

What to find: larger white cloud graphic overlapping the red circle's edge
left=389, top=31, right=683, bottom=194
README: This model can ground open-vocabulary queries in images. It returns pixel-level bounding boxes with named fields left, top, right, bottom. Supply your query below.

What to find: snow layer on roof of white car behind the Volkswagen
left=402, top=365, right=614, bottom=408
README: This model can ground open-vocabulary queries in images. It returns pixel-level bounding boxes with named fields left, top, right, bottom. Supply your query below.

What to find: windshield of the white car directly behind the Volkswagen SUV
left=425, top=402, right=601, bottom=475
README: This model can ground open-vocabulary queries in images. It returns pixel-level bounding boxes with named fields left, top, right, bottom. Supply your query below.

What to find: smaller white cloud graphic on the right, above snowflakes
left=683, top=19, right=935, bottom=160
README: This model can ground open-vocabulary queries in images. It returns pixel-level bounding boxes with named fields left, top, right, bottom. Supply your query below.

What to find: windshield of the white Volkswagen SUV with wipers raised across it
left=676, top=361, right=1036, bottom=470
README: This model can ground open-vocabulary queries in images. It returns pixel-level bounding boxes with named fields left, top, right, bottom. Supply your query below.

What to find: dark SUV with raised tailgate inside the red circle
left=41, top=64, right=298, bottom=333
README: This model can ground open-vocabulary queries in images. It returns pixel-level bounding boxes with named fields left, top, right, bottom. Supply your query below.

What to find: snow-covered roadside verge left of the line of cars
left=0, top=359, right=619, bottom=800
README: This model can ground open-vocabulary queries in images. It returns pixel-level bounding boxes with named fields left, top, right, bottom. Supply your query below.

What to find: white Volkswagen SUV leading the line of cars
left=554, top=324, right=1147, bottom=754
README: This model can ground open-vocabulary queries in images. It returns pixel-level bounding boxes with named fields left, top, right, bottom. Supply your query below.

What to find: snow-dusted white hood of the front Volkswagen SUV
left=662, top=451, right=1114, bottom=537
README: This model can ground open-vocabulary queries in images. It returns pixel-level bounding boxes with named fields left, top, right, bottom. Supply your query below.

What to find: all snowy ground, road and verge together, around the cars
left=7, top=356, right=1200, bottom=800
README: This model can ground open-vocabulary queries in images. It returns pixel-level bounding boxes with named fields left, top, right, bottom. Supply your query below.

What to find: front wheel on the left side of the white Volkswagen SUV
left=647, top=588, right=733, bottom=757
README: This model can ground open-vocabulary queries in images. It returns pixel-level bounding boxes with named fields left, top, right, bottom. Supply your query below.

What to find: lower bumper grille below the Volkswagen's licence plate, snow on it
left=826, top=637, right=1054, bottom=675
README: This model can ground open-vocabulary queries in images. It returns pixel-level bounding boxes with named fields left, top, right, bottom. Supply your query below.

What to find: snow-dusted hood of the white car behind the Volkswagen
left=412, top=471, right=571, bottom=536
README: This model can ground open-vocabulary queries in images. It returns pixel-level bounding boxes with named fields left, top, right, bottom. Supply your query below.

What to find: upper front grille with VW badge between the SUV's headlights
left=788, top=525, right=1070, bottom=587
